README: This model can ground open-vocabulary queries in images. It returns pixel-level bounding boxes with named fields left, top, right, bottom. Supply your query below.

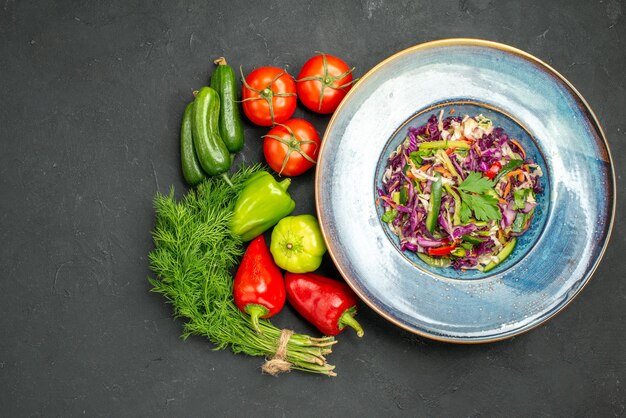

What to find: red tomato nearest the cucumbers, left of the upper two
left=242, top=67, right=297, bottom=126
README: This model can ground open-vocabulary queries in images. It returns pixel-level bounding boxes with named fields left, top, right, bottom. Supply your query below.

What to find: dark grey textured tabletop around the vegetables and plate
left=0, top=0, right=626, bottom=417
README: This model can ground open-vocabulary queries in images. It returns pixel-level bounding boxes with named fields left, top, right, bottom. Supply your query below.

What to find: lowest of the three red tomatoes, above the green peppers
left=263, top=119, right=320, bottom=176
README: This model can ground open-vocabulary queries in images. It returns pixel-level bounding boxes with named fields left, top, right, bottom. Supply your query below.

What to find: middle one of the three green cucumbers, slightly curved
left=191, top=87, right=231, bottom=176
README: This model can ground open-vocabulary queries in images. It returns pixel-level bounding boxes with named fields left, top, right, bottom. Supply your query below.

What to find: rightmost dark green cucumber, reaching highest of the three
left=211, top=57, right=243, bottom=154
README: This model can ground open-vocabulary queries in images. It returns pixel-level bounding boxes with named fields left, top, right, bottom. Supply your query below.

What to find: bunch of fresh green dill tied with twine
left=149, top=164, right=336, bottom=376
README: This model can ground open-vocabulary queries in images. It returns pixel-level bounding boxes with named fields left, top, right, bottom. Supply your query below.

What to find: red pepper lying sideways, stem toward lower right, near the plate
left=285, top=273, right=363, bottom=337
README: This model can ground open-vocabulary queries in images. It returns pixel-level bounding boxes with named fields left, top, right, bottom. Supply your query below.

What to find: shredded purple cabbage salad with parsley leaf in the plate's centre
left=377, top=110, right=542, bottom=272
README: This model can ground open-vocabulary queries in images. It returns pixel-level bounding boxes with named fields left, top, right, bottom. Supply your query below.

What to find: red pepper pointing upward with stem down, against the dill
left=233, top=235, right=286, bottom=332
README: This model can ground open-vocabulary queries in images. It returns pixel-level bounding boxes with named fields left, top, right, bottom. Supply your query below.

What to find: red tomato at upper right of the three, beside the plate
left=297, top=54, right=354, bottom=113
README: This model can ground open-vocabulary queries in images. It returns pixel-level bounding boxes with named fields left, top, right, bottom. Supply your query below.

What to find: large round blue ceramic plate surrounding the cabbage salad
left=316, top=39, right=615, bottom=343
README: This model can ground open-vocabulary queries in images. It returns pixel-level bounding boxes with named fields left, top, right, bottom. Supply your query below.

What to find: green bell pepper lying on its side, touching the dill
left=231, top=171, right=296, bottom=241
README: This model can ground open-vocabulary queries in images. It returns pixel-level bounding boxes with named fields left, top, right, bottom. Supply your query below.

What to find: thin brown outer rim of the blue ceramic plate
left=315, top=38, right=617, bottom=344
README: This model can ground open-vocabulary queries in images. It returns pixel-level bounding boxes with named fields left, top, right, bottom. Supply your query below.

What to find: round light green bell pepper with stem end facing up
left=270, top=215, right=326, bottom=273
